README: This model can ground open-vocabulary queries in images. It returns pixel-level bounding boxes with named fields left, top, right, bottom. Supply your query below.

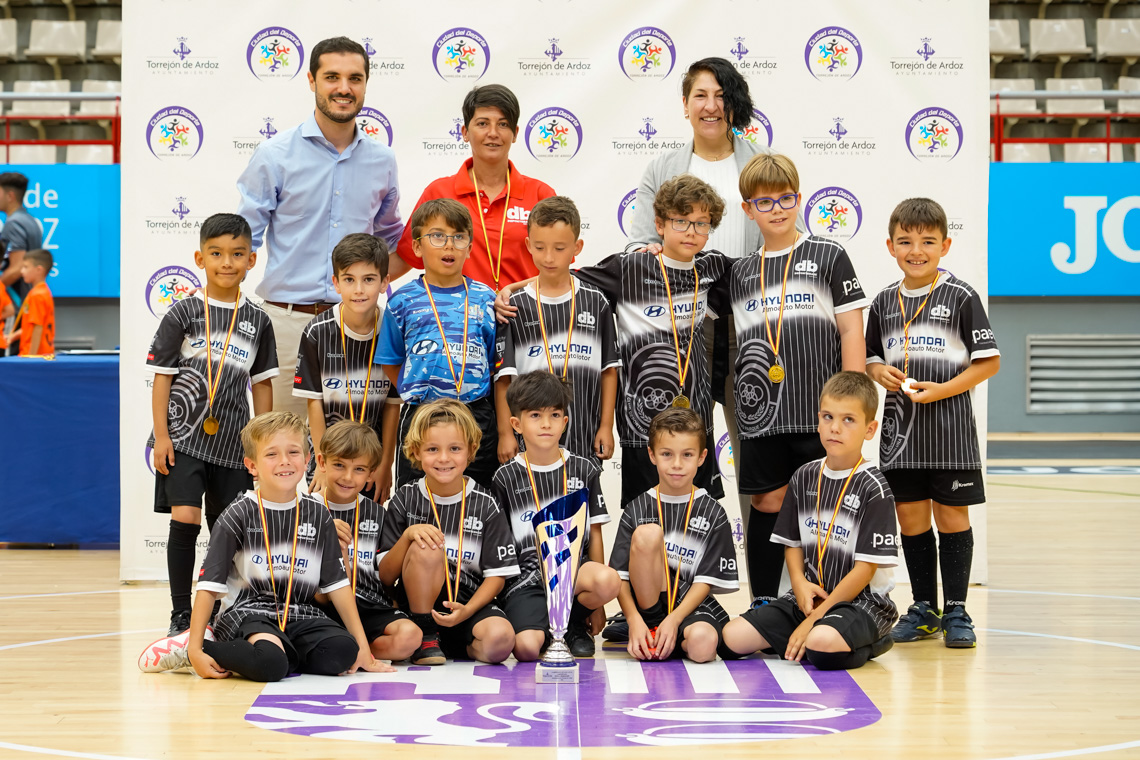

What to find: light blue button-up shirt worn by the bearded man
left=237, top=115, right=404, bottom=303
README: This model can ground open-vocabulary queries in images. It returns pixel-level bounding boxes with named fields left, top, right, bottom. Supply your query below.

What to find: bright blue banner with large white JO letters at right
left=990, top=163, right=1140, bottom=296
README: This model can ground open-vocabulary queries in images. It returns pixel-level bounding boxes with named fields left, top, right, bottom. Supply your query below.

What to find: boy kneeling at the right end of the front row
left=722, top=371, right=898, bottom=670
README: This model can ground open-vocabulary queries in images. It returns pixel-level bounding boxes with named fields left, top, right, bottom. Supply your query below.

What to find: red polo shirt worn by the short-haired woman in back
left=396, top=158, right=555, bottom=289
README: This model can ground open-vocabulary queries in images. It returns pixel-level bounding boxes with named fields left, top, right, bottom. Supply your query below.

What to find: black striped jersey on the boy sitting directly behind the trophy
left=495, top=449, right=610, bottom=596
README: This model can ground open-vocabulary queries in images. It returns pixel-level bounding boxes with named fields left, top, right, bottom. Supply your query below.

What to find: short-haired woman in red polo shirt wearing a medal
left=390, top=84, right=555, bottom=291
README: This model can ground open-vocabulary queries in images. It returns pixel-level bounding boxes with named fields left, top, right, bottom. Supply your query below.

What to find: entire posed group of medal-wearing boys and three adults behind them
left=139, top=36, right=1000, bottom=681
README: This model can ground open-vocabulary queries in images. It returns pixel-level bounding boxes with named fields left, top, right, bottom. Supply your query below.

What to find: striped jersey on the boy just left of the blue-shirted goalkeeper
left=293, top=304, right=400, bottom=434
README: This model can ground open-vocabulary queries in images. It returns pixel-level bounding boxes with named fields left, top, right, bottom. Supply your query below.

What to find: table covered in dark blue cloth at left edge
left=0, top=356, right=119, bottom=544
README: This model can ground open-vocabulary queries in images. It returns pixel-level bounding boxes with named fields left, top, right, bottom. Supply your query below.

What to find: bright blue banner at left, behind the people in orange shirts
left=3, top=164, right=120, bottom=299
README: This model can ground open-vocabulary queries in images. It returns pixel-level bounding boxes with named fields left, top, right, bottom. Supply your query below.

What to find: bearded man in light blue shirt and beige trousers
left=237, top=36, right=404, bottom=416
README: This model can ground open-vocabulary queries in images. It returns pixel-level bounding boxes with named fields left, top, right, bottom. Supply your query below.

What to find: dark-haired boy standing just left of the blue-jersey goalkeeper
left=293, top=232, right=400, bottom=502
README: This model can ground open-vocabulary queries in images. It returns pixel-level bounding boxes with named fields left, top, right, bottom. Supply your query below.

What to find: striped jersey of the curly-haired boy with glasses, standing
left=577, top=251, right=732, bottom=447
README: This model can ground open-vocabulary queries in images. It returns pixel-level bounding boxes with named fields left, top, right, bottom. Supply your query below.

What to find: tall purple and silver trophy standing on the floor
left=531, top=489, right=589, bottom=684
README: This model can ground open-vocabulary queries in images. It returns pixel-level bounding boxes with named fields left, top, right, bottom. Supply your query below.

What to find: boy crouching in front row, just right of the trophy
left=610, top=407, right=739, bottom=662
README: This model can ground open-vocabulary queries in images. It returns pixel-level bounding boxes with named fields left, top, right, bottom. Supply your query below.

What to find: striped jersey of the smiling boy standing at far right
left=866, top=271, right=1001, bottom=469
